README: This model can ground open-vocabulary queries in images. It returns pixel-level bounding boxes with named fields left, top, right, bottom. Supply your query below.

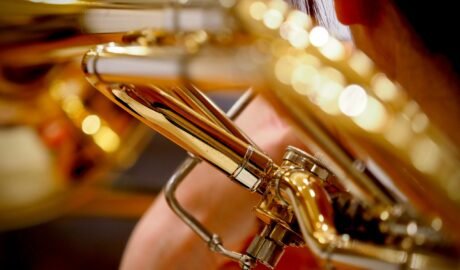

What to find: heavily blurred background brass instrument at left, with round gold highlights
left=0, top=58, right=151, bottom=230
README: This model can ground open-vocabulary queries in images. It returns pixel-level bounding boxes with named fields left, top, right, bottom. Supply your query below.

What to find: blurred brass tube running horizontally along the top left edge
left=0, top=0, right=231, bottom=65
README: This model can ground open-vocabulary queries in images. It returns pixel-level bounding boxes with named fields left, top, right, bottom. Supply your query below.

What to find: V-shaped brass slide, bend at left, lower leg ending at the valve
left=83, top=44, right=274, bottom=193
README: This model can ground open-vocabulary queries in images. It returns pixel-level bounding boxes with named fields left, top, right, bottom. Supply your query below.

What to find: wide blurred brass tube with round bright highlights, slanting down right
left=235, top=0, right=460, bottom=239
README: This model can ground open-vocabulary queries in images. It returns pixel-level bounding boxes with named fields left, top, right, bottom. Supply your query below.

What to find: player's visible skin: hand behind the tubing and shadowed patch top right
left=121, top=0, right=460, bottom=269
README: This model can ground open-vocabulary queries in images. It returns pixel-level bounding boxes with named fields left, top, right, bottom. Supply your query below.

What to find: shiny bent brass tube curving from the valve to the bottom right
left=280, top=170, right=460, bottom=269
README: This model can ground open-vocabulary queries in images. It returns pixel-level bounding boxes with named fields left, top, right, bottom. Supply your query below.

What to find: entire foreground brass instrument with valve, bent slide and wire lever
left=0, top=0, right=460, bottom=269
